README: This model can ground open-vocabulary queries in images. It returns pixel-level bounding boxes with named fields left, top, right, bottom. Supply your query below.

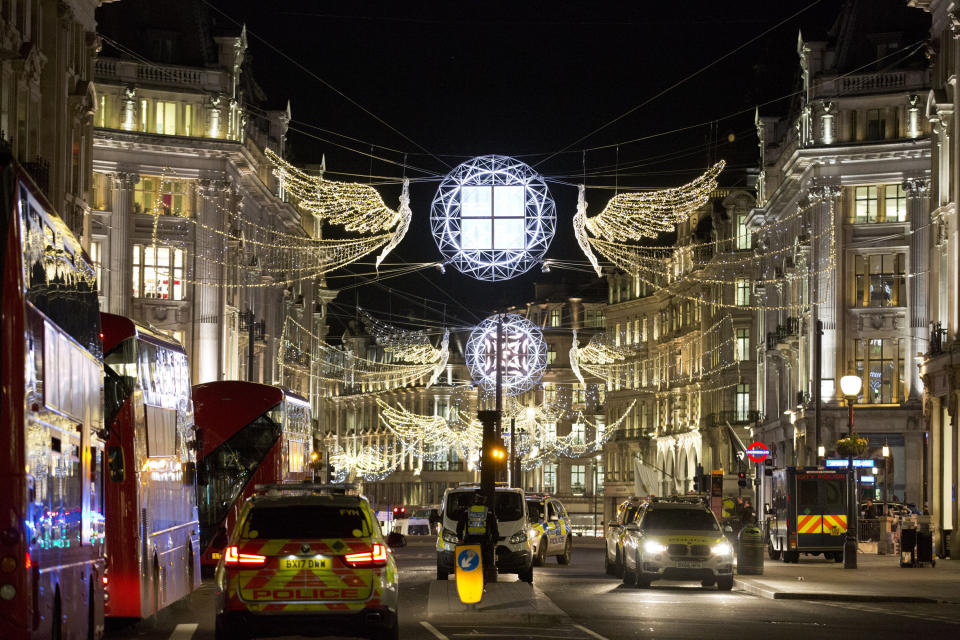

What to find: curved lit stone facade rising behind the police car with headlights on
left=604, top=189, right=760, bottom=518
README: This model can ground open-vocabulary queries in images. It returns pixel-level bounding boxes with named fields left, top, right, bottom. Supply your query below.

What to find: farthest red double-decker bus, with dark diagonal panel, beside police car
left=193, top=381, right=313, bottom=565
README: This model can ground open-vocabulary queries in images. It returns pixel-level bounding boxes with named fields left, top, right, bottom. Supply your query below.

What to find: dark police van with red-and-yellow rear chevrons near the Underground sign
left=765, top=467, right=849, bottom=562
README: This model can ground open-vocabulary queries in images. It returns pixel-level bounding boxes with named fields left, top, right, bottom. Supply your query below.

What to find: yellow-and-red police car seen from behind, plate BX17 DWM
left=215, top=484, right=399, bottom=640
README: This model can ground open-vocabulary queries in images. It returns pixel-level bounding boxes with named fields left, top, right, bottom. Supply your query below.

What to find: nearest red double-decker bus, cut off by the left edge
left=0, top=156, right=104, bottom=640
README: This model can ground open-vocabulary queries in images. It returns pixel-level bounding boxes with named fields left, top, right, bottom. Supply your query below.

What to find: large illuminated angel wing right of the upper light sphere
left=573, top=161, right=725, bottom=276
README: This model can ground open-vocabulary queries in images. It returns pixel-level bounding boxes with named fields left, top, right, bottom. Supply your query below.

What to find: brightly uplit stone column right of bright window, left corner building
left=190, top=180, right=229, bottom=384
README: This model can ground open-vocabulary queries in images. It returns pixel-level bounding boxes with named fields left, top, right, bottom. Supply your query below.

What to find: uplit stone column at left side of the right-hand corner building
left=808, top=178, right=846, bottom=403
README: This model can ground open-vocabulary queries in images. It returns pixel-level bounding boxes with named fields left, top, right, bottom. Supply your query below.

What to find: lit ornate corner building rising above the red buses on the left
left=90, top=1, right=332, bottom=396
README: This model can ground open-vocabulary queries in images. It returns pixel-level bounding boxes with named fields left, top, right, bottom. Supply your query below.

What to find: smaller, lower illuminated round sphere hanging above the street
left=466, top=313, right=547, bottom=396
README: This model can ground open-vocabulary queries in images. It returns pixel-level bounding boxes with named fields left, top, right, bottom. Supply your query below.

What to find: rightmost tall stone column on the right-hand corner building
left=903, top=178, right=930, bottom=402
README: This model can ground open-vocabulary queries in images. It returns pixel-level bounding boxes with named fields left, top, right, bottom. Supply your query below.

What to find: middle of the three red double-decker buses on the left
left=100, top=313, right=200, bottom=618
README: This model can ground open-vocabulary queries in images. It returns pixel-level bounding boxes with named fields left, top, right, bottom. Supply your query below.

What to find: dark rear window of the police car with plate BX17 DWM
left=240, top=504, right=371, bottom=538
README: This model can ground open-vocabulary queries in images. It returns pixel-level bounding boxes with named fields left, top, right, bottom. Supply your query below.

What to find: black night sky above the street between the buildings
left=199, top=0, right=841, bottom=336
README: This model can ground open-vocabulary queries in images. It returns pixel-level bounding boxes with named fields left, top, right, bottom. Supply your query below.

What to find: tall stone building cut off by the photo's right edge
left=909, top=0, right=960, bottom=558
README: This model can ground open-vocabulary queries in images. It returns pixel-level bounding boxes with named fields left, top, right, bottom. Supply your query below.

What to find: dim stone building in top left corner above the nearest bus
left=0, top=0, right=107, bottom=242
